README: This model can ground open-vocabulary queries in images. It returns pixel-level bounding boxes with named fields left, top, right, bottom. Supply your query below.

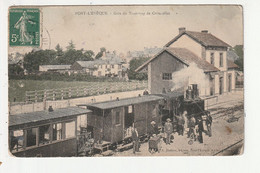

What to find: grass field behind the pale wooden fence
left=8, top=80, right=147, bottom=102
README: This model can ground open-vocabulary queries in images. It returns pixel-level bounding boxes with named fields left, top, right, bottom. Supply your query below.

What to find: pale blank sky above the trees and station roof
left=9, top=5, right=243, bottom=53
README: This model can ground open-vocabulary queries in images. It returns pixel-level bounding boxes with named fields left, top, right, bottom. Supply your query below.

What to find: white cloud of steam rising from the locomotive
left=172, top=63, right=210, bottom=91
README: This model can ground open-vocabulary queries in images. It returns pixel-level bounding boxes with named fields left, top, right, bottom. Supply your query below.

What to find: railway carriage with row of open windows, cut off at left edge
left=9, top=107, right=91, bottom=157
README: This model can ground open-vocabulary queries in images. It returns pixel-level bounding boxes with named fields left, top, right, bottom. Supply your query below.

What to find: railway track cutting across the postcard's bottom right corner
left=213, top=139, right=244, bottom=156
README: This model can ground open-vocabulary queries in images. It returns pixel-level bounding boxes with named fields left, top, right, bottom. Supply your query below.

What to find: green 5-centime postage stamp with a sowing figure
left=9, top=8, right=40, bottom=46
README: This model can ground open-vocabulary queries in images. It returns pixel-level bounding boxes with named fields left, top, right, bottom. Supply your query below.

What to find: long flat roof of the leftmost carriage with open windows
left=9, top=107, right=91, bottom=127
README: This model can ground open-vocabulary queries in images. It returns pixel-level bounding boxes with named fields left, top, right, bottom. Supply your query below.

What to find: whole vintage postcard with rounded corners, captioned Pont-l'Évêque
left=8, top=5, right=244, bottom=157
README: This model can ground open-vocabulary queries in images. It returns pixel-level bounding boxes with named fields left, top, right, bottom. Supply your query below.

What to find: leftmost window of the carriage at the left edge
left=10, top=130, right=24, bottom=151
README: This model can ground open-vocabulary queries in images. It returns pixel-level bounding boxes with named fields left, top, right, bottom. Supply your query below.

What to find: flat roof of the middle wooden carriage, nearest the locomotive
left=86, top=95, right=163, bottom=109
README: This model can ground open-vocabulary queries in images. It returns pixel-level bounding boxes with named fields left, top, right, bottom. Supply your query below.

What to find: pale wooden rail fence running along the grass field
left=25, top=81, right=147, bottom=103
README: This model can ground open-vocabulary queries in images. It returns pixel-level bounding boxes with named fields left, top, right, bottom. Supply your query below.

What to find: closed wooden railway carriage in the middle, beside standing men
left=86, top=95, right=163, bottom=144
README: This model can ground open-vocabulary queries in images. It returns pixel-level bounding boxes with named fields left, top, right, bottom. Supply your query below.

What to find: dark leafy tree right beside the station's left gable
left=128, top=57, right=149, bottom=80
